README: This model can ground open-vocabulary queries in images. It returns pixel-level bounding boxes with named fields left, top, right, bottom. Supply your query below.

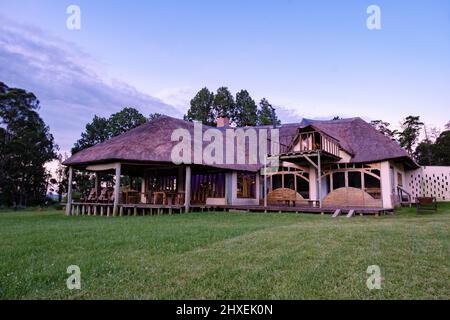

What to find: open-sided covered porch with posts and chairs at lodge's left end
left=65, top=162, right=229, bottom=216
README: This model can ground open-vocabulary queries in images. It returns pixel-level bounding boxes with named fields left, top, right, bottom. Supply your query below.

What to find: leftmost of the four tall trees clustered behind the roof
left=184, top=87, right=215, bottom=126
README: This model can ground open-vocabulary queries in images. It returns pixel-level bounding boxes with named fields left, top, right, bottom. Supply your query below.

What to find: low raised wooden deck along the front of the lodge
left=63, top=202, right=392, bottom=216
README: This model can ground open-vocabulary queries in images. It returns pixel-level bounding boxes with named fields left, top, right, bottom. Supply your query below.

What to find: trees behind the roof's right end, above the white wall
left=371, top=116, right=450, bottom=166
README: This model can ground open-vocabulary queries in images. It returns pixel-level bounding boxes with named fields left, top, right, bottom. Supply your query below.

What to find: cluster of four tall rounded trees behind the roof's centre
left=184, top=87, right=281, bottom=127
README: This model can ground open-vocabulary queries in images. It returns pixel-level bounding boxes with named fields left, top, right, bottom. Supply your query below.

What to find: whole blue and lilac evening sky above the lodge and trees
left=0, top=0, right=450, bottom=151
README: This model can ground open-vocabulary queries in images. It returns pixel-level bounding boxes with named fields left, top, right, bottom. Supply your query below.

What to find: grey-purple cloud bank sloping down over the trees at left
left=0, top=17, right=181, bottom=151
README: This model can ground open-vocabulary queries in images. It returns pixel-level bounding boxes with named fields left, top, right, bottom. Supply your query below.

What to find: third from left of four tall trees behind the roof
left=232, top=90, right=258, bottom=127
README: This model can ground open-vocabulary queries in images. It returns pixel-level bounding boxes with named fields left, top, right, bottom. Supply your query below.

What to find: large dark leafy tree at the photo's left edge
left=0, top=82, right=57, bottom=206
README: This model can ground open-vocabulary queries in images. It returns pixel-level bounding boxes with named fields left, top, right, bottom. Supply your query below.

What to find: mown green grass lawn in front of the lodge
left=0, top=204, right=450, bottom=299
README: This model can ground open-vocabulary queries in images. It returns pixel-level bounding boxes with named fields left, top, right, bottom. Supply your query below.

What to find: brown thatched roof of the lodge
left=64, top=116, right=418, bottom=171
